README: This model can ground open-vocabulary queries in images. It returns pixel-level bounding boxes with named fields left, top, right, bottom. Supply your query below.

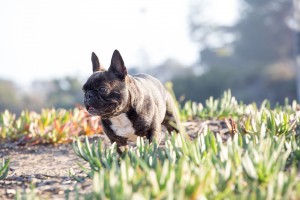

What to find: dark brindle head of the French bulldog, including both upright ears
left=82, top=50, right=129, bottom=118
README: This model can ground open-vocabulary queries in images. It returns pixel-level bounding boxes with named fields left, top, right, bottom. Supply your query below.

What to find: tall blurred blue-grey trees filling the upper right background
left=173, top=0, right=299, bottom=103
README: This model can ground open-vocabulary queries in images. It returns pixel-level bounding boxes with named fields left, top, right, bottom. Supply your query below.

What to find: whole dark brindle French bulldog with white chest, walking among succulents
left=83, top=50, right=180, bottom=152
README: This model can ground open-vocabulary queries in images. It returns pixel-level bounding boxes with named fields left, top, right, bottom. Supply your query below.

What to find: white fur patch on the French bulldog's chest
left=110, top=113, right=137, bottom=141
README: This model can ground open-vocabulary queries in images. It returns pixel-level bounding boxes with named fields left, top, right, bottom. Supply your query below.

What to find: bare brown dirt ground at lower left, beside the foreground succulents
left=0, top=136, right=110, bottom=199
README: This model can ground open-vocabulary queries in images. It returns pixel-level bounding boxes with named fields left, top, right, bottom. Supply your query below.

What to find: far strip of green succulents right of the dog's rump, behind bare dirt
left=180, top=90, right=298, bottom=120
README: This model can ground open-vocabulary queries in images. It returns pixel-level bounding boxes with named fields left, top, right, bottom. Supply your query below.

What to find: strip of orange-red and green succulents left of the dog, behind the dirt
left=0, top=107, right=102, bottom=144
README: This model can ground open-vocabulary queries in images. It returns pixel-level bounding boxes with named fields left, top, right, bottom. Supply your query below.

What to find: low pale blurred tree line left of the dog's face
left=0, top=77, right=83, bottom=114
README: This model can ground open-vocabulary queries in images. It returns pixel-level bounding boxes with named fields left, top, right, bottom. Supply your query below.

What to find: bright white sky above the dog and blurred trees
left=0, top=0, right=237, bottom=84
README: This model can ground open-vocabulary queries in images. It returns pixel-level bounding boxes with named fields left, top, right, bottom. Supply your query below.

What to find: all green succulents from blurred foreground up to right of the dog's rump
left=73, top=91, right=300, bottom=199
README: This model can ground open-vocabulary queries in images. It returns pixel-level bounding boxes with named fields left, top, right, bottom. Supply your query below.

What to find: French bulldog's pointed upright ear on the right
left=108, top=50, right=127, bottom=79
